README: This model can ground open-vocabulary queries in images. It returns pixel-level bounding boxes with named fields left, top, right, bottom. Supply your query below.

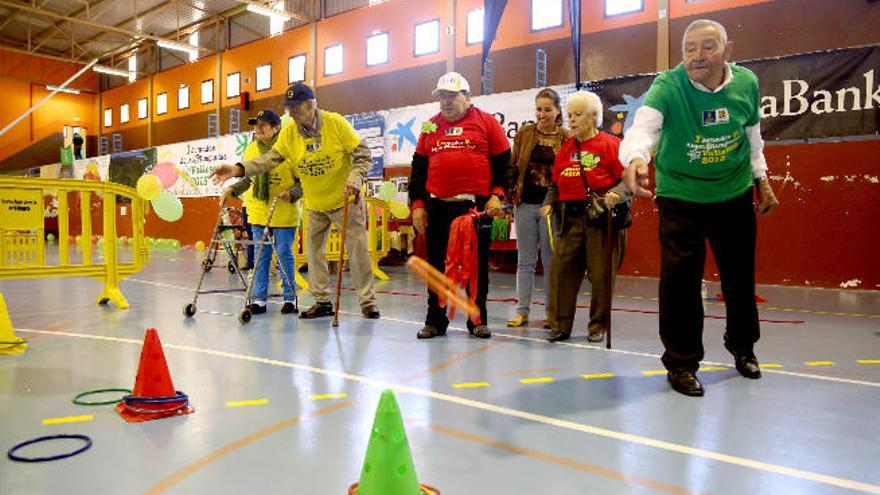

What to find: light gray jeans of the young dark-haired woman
left=514, top=203, right=553, bottom=316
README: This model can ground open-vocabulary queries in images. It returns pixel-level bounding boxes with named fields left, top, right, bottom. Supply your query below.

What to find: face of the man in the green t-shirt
left=682, top=26, right=730, bottom=89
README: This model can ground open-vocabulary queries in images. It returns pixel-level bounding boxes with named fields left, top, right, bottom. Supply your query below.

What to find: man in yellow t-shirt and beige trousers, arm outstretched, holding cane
left=211, top=83, right=380, bottom=318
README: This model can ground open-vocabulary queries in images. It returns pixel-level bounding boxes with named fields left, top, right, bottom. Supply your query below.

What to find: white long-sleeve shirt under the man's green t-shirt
left=618, top=64, right=767, bottom=179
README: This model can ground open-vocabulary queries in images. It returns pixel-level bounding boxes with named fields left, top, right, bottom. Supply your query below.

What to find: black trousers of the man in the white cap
left=425, top=198, right=492, bottom=331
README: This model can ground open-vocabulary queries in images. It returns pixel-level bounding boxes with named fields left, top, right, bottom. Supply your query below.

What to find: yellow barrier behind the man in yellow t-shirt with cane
left=293, top=198, right=391, bottom=289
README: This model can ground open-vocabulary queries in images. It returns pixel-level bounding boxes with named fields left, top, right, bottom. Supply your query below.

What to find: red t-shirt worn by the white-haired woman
left=553, top=131, right=623, bottom=201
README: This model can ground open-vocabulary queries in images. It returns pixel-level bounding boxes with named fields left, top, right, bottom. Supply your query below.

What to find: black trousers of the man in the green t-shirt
left=657, top=189, right=760, bottom=371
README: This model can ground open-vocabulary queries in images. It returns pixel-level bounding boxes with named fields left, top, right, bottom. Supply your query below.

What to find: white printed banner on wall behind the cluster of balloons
left=153, top=133, right=252, bottom=198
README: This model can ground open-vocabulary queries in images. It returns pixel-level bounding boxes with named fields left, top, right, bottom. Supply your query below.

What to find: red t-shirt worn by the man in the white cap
left=416, top=107, right=510, bottom=198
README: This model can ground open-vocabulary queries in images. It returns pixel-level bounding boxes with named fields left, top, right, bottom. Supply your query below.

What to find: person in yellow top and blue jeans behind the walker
left=225, top=110, right=302, bottom=314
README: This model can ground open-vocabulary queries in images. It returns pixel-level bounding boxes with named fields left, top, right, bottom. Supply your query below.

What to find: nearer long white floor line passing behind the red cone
left=17, top=329, right=880, bottom=494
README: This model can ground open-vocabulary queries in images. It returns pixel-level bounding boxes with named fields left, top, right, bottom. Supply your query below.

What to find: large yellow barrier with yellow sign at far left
left=0, top=176, right=150, bottom=309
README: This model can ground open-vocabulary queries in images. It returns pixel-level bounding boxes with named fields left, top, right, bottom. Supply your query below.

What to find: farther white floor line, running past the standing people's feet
left=127, top=278, right=880, bottom=388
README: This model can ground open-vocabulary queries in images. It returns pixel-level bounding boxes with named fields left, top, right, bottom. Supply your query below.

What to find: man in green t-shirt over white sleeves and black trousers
left=620, top=20, right=779, bottom=396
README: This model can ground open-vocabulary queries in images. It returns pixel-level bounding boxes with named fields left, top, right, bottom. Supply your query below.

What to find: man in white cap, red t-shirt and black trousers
left=409, top=72, right=510, bottom=339
